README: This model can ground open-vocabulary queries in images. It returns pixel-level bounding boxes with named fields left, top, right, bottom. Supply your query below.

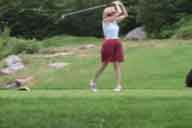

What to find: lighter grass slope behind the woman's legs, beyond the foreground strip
left=12, top=40, right=192, bottom=89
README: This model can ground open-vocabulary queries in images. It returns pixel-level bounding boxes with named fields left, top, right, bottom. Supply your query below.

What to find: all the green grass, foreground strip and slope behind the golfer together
left=0, top=38, right=192, bottom=128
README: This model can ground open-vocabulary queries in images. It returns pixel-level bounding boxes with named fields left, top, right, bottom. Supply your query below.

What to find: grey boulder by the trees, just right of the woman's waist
left=125, top=27, right=147, bottom=40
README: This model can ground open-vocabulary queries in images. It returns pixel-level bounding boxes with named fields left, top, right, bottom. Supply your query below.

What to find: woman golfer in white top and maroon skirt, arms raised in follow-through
left=90, top=1, right=128, bottom=92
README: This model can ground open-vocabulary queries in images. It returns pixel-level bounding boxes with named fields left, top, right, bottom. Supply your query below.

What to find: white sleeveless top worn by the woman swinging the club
left=102, top=21, right=119, bottom=39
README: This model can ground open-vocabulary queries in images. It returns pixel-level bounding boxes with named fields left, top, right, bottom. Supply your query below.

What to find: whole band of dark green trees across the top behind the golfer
left=0, top=0, right=192, bottom=39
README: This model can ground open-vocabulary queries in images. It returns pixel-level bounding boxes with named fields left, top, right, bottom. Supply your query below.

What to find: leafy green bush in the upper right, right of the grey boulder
left=138, top=0, right=192, bottom=38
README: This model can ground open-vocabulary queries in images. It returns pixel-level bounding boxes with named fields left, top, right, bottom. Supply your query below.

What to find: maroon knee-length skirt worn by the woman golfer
left=101, top=39, right=124, bottom=63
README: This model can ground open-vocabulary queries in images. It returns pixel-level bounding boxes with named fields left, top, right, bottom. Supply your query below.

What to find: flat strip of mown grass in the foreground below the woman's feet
left=0, top=89, right=192, bottom=128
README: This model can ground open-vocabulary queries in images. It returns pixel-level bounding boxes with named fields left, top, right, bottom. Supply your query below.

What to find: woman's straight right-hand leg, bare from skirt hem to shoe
left=114, top=62, right=122, bottom=88
